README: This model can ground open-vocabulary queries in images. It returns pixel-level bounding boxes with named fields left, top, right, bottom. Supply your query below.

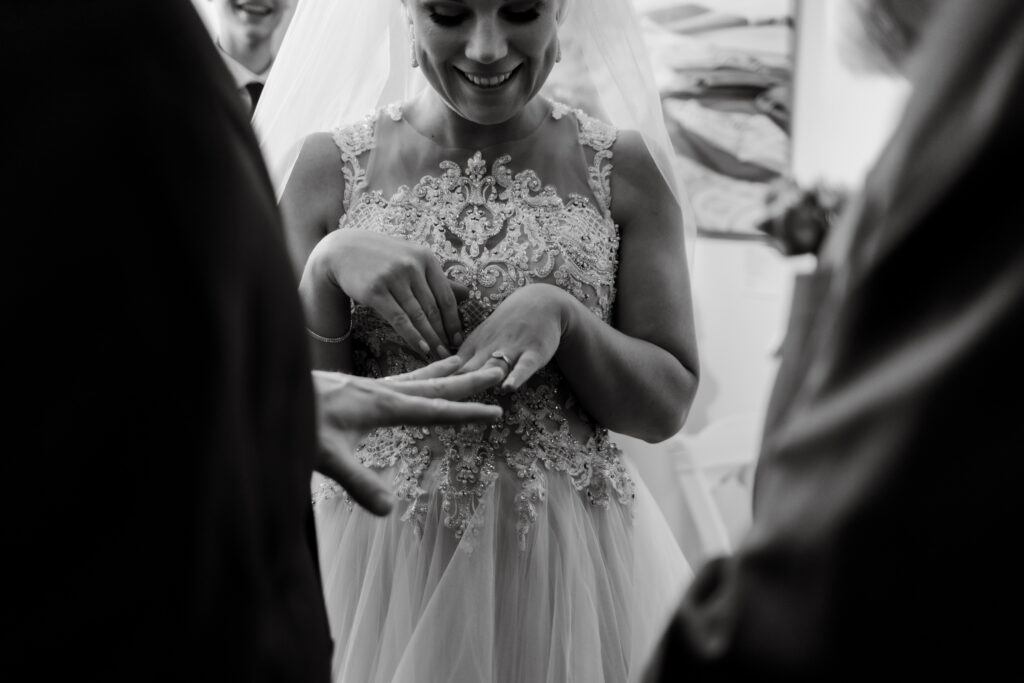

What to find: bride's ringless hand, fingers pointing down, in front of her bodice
left=310, top=228, right=463, bottom=358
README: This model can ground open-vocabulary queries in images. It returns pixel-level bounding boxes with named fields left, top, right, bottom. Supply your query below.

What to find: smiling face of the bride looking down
left=405, top=0, right=560, bottom=125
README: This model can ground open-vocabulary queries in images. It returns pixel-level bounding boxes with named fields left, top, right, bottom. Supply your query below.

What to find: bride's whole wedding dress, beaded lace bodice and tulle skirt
left=313, top=103, right=690, bottom=683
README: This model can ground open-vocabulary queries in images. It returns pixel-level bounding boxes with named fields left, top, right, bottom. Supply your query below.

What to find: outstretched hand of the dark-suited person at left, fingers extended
left=312, top=356, right=505, bottom=515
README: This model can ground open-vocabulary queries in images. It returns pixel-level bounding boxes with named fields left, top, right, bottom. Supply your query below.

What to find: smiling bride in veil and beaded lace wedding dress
left=256, top=0, right=697, bottom=683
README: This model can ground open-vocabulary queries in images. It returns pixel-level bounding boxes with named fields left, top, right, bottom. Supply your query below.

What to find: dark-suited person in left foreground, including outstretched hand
left=0, top=0, right=504, bottom=682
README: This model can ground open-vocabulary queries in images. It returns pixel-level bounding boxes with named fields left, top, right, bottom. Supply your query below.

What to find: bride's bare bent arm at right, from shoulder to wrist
left=556, top=131, right=699, bottom=441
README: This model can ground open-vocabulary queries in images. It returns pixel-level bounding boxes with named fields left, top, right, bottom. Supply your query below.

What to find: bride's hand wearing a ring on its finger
left=457, top=283, right=571, bottom=391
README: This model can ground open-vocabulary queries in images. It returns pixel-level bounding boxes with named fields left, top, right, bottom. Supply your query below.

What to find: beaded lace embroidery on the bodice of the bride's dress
left=315, top=103, right=633, bottom=547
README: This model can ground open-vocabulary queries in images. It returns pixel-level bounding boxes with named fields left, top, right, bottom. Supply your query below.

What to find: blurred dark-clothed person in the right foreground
left=648, top=0, right=1024, bottom=682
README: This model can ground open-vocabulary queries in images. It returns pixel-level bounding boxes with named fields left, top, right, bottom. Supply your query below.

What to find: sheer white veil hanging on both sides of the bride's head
left=253, top=0, right=696, bottom=265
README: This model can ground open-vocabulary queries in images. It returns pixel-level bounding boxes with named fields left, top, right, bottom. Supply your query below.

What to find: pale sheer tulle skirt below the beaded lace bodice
left=316, top=454, right=691, bottom=683
